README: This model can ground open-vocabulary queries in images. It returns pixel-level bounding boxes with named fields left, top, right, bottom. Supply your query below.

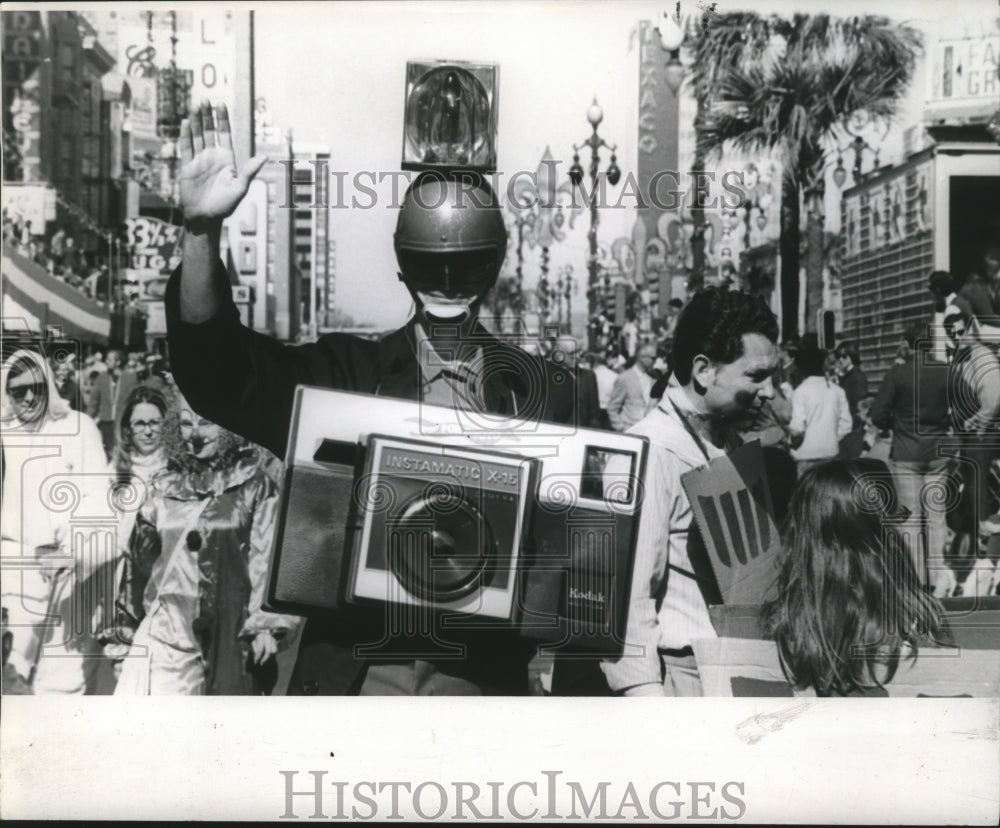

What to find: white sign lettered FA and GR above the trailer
left=929, top=35, right=1000, bottom=106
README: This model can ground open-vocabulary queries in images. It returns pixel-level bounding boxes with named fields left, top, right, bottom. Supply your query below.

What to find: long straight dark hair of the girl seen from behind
left=761, top=459, right=945, bottom=696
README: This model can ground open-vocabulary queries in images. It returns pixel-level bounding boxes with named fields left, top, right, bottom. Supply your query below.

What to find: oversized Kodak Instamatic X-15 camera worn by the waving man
left=267, top=387, right=647, bottom=656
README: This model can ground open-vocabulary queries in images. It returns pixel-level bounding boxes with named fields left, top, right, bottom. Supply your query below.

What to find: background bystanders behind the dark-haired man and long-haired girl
left=583, top=262, right=1000, bottom=612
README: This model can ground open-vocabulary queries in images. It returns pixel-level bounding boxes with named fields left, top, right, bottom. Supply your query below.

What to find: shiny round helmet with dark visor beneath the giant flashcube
left=394, top=172, right=507, bottom=297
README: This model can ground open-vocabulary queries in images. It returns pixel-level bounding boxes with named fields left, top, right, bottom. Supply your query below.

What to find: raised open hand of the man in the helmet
left=178, top=101, right=267, bottom=225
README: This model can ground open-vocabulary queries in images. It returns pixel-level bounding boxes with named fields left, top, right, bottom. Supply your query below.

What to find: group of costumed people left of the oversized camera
left=0, top=342, right=299, bottom=695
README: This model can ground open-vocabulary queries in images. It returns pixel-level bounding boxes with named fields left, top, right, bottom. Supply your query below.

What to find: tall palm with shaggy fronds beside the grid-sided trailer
left=695, top=13, right=921, bottom=336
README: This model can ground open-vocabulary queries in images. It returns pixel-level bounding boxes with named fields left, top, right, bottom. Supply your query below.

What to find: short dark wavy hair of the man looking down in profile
left=671, top=287, right=778, bottom=385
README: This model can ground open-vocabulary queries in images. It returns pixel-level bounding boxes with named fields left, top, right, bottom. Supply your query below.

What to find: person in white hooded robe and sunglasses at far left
left=0, top=349, right=118, bottom=694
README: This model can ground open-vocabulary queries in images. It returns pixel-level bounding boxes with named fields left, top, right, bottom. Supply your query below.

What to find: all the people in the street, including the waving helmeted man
left=2, top=103, right=1000, bottom=696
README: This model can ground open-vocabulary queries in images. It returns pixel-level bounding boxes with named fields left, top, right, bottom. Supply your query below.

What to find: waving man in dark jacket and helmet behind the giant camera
left=166, top=103, right=574, bottom=695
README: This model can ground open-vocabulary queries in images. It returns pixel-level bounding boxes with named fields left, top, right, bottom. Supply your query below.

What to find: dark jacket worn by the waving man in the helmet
left=165, top=262, right=575, bottom=695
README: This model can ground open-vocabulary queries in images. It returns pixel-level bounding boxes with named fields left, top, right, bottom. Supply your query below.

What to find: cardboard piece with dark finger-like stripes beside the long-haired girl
left=681, top=441, right=778, bottom=604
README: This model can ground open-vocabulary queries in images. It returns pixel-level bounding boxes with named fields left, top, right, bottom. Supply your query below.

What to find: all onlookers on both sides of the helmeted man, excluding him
left=3, top=289, right=1000, bottom=695
